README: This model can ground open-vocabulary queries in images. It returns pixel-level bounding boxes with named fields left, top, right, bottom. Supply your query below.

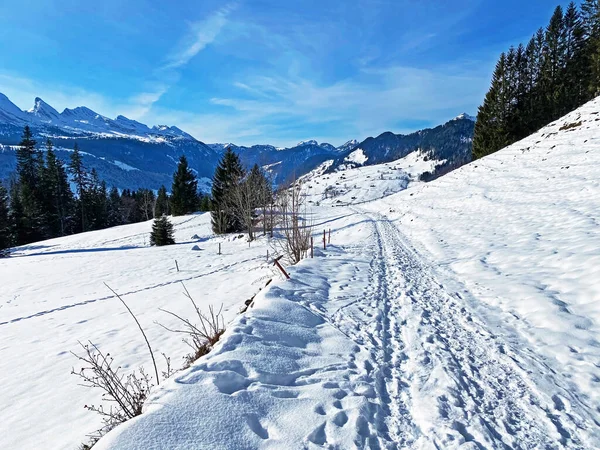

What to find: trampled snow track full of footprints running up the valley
left=334, top=212, right=595, bottom=449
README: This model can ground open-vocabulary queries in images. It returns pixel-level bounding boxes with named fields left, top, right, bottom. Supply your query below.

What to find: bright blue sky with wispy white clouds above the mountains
left=0, top=0, right=567, bottom=146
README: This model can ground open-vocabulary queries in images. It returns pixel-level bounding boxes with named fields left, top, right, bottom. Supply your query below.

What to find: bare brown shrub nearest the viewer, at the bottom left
left=71, top=342, right=152, bottom=449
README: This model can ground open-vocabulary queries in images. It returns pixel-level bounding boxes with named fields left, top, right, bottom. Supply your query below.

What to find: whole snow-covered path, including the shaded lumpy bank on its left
left=100, top=208, right=600, bottom=449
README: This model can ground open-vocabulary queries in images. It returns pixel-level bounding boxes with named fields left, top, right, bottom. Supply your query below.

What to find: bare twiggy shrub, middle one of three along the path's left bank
left=159, top=283, right=225, bottom=369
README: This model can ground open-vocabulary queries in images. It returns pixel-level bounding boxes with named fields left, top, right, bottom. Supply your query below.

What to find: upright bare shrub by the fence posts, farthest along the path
left=272, top=182, right=313, bottom=264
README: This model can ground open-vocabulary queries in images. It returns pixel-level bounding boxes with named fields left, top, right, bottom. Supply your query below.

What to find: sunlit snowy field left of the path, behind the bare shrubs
left=0, top=214, right=271, bottom=449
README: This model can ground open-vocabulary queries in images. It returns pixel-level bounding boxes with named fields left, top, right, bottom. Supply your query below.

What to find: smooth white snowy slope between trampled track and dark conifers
left=371, top=99, right=600, bottom=443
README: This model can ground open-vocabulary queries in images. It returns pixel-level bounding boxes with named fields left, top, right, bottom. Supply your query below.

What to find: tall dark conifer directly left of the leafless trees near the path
left=211, top=147, right=245, bottom=234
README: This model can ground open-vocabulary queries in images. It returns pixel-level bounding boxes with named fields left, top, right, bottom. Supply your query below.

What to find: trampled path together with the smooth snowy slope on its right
left=99, top=97, right=600, bottom=449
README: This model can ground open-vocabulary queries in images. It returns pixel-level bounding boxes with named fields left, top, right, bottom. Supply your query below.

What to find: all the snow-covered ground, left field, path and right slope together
left=0, top=99, right=600, bottom=450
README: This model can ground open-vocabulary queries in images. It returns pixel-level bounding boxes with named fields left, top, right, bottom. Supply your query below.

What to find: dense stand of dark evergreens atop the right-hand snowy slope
left=473, top=0, right=600, bottom=159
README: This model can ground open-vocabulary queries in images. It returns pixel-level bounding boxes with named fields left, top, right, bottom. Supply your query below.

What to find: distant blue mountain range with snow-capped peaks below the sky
left=0, top=94, right=472, bottom=189
